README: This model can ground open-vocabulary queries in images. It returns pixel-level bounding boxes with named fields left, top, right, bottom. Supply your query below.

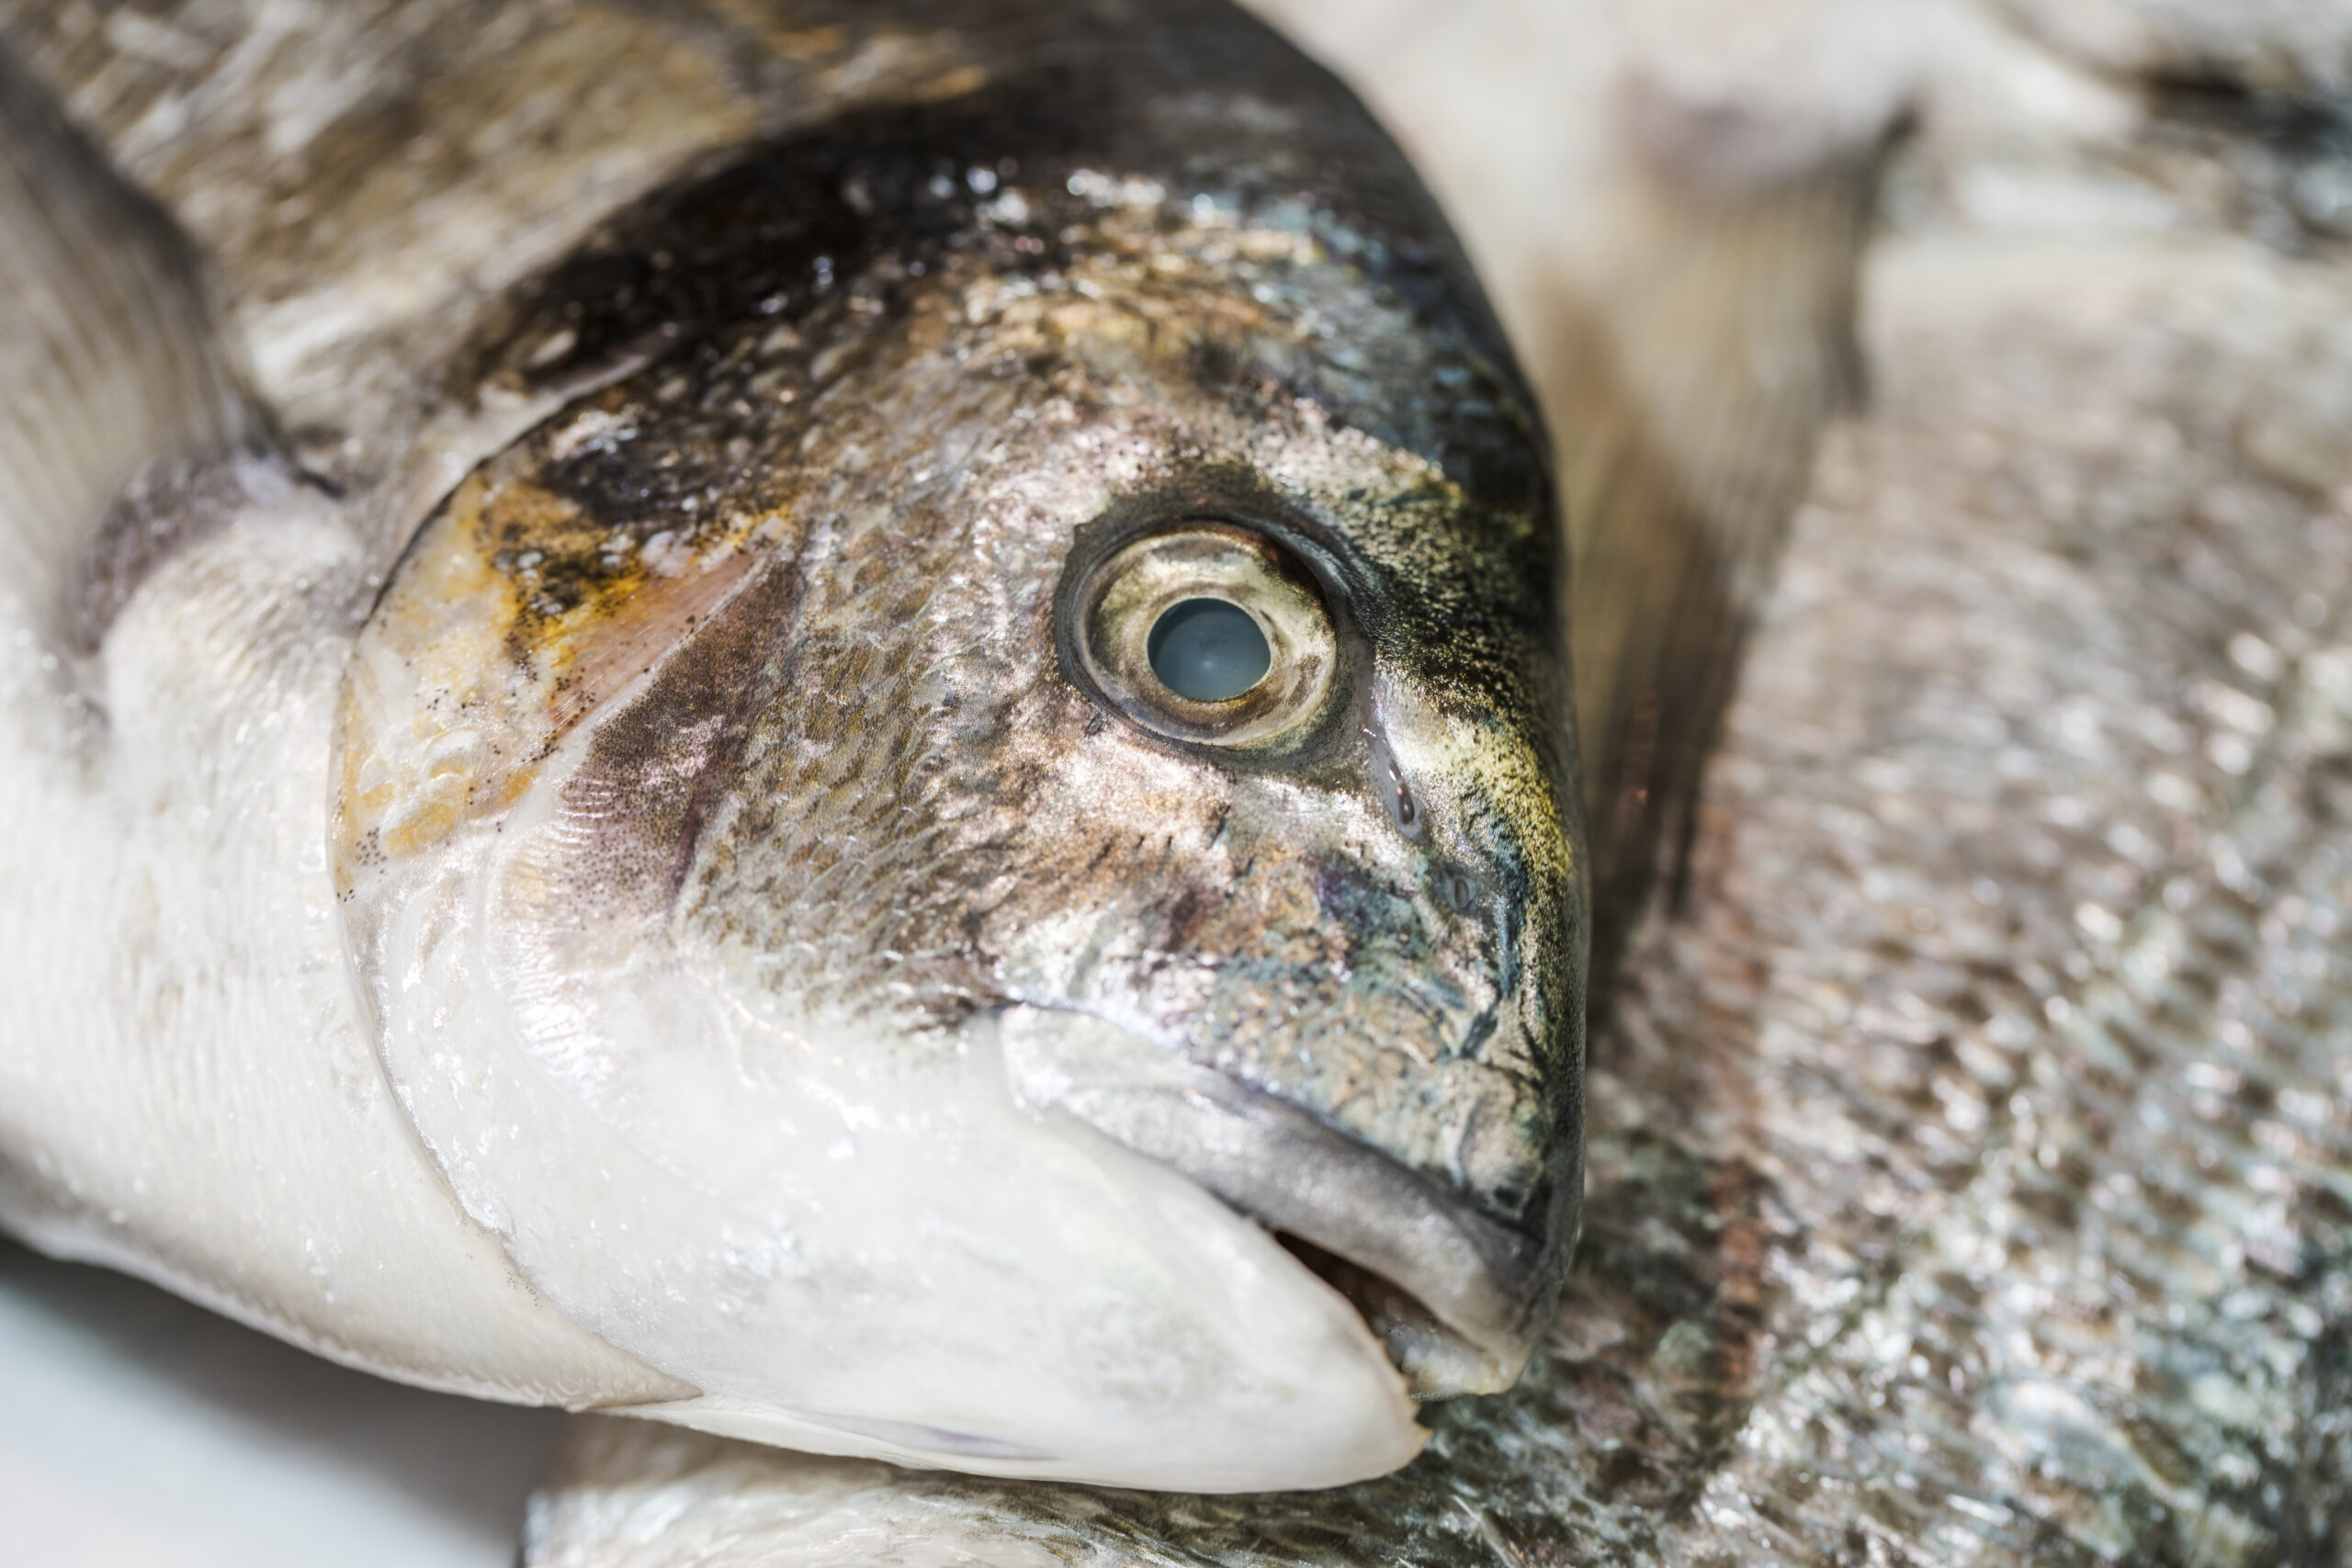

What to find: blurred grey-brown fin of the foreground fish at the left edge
left=0, top=47, right=266, bottom=642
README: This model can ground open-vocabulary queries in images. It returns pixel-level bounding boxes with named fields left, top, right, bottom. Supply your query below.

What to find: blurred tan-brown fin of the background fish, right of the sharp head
left=1541, top=71, right=1903, bottom=1001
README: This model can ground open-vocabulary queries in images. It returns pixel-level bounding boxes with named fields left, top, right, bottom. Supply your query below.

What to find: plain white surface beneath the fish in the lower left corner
left=0, top=1241, right=555, bottom=1568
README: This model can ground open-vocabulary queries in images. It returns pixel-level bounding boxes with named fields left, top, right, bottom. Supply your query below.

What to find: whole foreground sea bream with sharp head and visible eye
left=0, top=0, right=1588, bottom=1491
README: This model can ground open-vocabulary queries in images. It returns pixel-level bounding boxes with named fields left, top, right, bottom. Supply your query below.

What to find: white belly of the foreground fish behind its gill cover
left=0, top=491, right=687, bottom=1404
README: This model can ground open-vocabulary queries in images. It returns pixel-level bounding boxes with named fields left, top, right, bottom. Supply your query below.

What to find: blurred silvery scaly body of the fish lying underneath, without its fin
left=526, top=7, right=2352, bottom=1568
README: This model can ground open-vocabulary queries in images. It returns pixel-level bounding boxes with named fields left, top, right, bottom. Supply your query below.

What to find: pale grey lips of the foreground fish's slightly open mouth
left=1002, top=1006, right=1559, bottom=1401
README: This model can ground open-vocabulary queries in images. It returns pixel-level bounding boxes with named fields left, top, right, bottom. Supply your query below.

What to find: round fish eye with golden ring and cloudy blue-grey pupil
left=1075, top=522, right=1339, bottom=750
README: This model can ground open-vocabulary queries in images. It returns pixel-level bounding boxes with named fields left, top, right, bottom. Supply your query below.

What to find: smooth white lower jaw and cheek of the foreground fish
left=345, top=780, right=1425, bottom=1491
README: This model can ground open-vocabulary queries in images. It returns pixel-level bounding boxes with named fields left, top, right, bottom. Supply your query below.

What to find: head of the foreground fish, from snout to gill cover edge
left=334, top=51, right=1583, bottom=1491
